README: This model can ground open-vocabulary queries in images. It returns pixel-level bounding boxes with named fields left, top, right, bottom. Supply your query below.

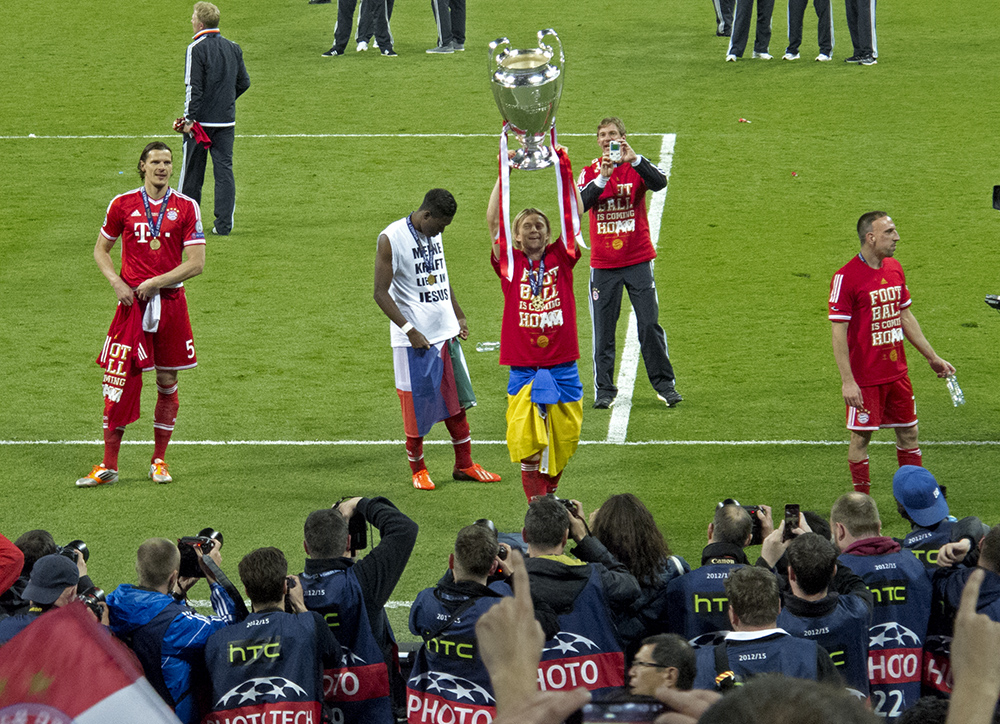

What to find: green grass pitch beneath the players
left=0, top=0, right=1000, bottom=638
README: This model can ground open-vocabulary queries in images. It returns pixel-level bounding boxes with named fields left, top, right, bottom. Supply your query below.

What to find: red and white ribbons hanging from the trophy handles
left=497, top=123, right=587, bottom=281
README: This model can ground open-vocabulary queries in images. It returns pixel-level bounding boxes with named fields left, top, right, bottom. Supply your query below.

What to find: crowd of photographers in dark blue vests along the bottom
left=0, top=466, right=1000, bottom=724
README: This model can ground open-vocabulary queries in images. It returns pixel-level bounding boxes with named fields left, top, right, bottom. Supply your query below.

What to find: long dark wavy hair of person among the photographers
left=591, top=493, right=670, bottom=585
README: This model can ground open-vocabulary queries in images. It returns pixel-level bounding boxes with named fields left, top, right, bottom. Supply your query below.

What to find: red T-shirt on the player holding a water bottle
left=829, top=254, right=912, bottom=387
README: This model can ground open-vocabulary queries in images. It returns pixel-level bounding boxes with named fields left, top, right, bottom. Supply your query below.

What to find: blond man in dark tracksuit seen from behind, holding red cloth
left=175, top=2, right=250, bottom=236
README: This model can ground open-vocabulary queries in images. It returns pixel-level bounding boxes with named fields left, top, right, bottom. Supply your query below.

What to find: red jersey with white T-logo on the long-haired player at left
left=101, top=189, right=205, bottom=288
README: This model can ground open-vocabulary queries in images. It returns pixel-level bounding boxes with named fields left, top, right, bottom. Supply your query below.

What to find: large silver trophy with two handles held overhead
left=489, top=29, right=566, bottom=170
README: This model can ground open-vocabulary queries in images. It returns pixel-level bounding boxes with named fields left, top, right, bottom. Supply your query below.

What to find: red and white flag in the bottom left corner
left=0, top=602, right=180, bottom=724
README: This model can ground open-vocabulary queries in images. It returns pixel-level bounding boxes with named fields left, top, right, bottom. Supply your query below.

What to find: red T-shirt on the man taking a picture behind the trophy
left=577, top=158, right=656, bottom=269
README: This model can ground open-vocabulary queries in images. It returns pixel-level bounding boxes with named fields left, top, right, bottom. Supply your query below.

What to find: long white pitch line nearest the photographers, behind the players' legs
left=0, top=440, right=1000, bottom=447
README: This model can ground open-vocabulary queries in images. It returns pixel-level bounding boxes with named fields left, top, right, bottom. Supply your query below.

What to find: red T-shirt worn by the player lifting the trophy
left=490, top=239, right=580, bottom=367
